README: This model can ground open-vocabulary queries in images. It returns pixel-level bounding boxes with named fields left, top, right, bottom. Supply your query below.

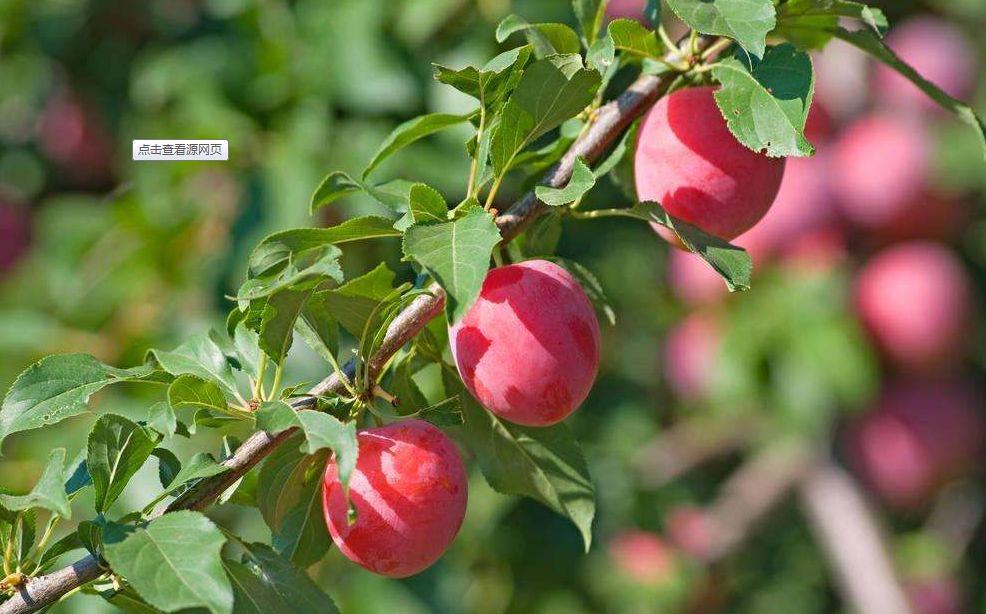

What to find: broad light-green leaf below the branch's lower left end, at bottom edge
left=103, top=511, right=233, bottom=614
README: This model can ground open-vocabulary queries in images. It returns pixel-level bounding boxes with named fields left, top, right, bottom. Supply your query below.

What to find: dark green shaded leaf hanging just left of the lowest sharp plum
left=257, top=433, right=331, bottom=566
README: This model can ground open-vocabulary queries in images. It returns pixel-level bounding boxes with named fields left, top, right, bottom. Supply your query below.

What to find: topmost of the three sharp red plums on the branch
left=634, top=87, right=784, bottom=240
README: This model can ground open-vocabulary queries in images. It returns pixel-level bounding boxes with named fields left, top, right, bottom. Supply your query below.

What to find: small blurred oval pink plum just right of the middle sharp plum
left=663, top=313, right=720, bottom=401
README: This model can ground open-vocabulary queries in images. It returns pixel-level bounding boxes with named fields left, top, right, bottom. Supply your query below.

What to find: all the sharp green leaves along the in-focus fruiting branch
left=0, top=0, right=981, bottom=613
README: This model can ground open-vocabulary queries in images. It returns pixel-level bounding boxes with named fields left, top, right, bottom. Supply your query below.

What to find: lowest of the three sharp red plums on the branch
left=322, top=420, right=467, bottom=578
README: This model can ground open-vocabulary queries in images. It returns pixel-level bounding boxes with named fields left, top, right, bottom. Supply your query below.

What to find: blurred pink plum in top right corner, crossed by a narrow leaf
left=874, top=17, right=976, bottom=111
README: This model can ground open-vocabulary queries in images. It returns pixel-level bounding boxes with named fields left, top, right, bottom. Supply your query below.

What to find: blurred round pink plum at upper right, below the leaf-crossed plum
left=830, top=114, right=928, bottom=229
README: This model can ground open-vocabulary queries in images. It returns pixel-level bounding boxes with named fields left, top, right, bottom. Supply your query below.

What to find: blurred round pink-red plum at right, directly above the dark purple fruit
left=855, top=241, right=971, bottom=370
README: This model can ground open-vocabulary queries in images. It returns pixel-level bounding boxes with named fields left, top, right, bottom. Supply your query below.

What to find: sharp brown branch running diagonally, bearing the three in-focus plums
left=0, top=38, right=710, bottom=614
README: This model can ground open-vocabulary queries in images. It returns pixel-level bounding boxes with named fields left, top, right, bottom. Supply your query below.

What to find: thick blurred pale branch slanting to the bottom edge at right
left=800, top=461, right=911, bottom=614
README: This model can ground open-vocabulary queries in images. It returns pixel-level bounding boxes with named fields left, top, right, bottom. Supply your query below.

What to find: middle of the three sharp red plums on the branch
left=449, top=260, right=599, bottom=426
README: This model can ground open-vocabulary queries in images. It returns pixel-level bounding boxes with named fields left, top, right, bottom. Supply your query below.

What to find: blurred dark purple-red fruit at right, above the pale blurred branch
left=848, top=380, right=986, bottom=509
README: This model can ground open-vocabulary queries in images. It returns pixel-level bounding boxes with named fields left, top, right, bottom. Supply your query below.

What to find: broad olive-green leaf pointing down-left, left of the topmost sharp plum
left=490, top=55, right=601, bottom=177
